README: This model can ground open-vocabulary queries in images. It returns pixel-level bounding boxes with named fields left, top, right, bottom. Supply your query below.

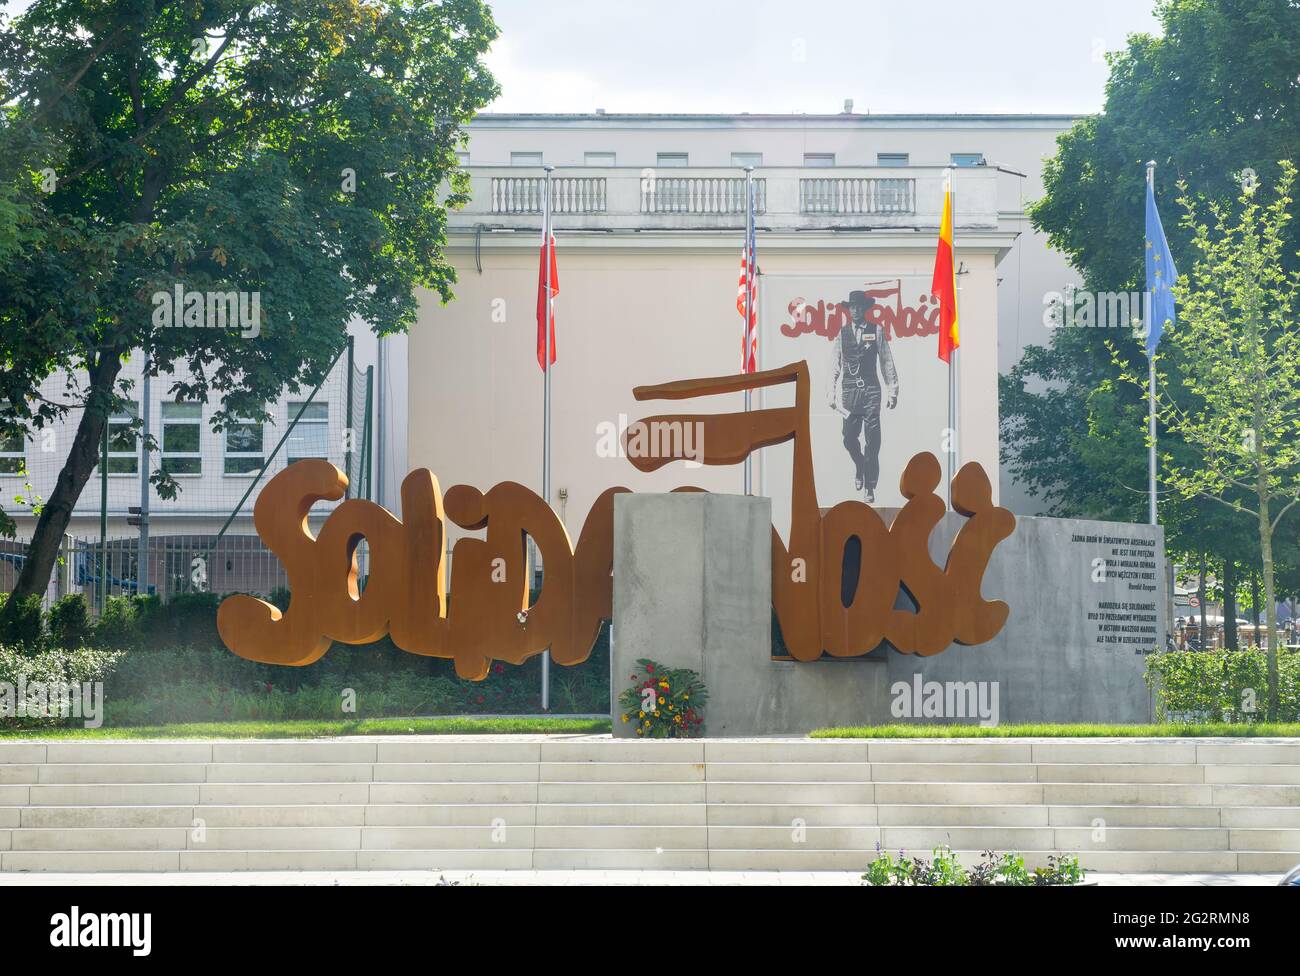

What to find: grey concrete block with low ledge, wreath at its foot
left=610, top=493, right=887, bottom=736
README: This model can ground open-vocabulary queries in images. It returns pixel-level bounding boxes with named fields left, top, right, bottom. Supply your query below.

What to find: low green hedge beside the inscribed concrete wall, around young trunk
left=1147, top=647, right=1300, bottom=723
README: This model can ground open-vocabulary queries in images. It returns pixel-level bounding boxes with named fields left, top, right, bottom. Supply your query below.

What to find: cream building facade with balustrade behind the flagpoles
left=403, top=112, right=1075, bottom=545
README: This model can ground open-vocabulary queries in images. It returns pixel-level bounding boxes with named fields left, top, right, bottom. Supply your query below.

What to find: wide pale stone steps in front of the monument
left=0, top=736, right=1300, bottom=872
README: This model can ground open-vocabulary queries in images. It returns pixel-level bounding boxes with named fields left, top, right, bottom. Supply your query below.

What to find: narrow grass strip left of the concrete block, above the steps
left=0, top=716, right=610, bottom=739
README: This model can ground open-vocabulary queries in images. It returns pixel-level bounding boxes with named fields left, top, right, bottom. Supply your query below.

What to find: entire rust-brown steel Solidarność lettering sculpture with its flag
left=217, top=361, right=1015, bottom=680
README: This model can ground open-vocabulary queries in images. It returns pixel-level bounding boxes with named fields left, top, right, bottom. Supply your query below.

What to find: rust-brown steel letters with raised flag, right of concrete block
left=624, top=363, right=1015, bottom=660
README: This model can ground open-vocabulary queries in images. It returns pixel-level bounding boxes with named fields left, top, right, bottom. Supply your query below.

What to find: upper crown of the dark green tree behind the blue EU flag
left=1030, top=0, right=1300, bottom=291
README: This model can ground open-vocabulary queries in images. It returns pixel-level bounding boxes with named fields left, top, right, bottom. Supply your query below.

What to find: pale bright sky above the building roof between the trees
left=489, top=0, right=1160, bottom=113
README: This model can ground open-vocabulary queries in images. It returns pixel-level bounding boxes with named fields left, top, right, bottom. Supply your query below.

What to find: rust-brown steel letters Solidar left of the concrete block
left=217, top=460, right=627, bottom=680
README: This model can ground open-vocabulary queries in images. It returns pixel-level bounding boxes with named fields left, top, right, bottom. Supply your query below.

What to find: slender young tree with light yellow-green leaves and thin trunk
left=1125, top=161, right=1300, bottom=721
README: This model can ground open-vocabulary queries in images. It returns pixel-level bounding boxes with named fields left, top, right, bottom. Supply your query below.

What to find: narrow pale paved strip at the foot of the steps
left=0, top=871, right=1282, bottom=888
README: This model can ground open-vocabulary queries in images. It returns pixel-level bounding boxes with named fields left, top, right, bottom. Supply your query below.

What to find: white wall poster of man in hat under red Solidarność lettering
left=759, top=274, right=948, bottom=524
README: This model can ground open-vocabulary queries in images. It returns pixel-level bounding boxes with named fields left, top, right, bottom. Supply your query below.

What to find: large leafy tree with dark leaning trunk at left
left=0, top=0, right=497, bottom=606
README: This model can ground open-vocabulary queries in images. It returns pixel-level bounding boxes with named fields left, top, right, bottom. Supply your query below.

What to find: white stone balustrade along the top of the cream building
left=452, top=166, right=997, bottom=230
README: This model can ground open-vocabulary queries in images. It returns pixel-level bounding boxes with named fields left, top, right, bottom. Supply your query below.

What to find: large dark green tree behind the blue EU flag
left=1000, top=0, right=1300, bottom=621
